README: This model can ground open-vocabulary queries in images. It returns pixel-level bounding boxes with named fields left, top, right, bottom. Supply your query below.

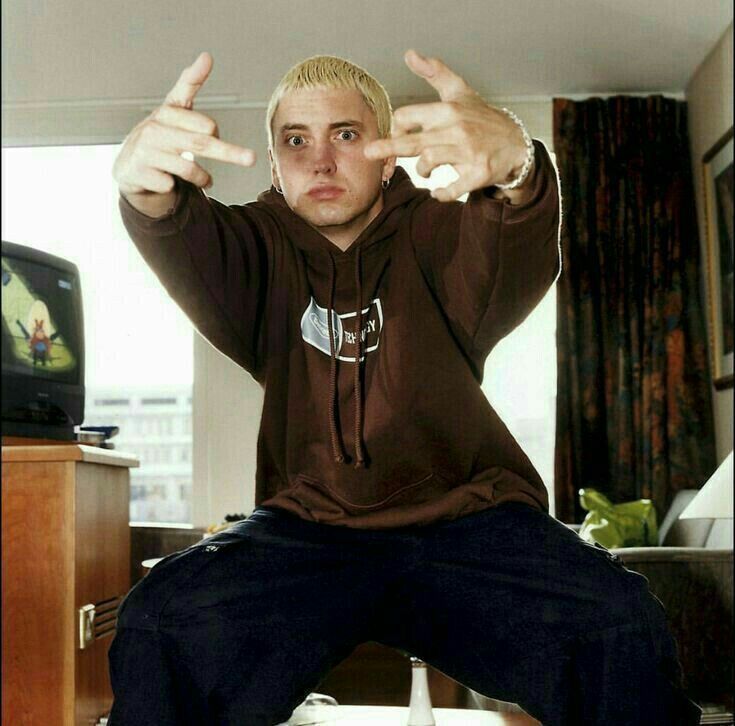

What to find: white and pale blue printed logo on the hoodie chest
left=301, top=297, right=383, bottom=363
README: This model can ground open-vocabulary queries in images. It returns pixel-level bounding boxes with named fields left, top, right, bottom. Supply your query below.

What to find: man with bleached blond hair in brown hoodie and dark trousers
left=110, top=51, right=699, bottom=726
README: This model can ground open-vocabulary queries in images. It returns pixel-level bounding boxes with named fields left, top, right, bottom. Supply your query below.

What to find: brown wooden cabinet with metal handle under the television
left=2, top=440, right=138, bottom=726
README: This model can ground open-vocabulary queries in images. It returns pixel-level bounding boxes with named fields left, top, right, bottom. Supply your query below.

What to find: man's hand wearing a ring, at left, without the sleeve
left=112, top=53, right=255, bottom=217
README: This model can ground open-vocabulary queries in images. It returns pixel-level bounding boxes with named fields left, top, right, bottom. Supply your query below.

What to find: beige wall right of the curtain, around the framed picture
left=686, top=25, right=733, bottom=462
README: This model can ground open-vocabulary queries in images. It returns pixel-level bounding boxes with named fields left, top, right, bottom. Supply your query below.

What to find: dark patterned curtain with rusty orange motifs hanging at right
left=554, top=96, right=716, bottom=522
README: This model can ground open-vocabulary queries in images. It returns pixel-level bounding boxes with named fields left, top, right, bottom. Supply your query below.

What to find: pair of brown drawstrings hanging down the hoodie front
left=327, top=247, right=365, bottom=469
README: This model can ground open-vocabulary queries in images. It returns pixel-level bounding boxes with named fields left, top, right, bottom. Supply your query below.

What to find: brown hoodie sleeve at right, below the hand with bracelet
left=412, top=141, right=561, bottom=375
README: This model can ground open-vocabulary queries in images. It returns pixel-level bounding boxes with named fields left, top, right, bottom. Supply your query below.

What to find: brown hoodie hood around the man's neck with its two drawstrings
left=258, top=167, right=429, bottom=468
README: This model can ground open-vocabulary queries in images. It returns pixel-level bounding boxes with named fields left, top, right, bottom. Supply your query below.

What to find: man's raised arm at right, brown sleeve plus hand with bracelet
left=365, top=51, right=561, bottom=378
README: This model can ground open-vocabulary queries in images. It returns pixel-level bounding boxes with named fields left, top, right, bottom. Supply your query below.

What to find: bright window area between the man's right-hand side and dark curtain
left=399, top=154, right=556, bottom=516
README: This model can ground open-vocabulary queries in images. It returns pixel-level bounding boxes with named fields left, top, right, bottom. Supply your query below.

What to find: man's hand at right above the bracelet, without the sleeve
left=365, top=50, right=532, bottom=202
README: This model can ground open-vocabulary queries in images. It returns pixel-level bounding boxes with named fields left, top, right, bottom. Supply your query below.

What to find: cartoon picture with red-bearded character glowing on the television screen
left=2, top=259, right=77, bottom=377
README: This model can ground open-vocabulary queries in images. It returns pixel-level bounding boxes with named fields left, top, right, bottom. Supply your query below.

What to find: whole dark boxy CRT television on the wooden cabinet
left=1, top=241, right=84, bottom=441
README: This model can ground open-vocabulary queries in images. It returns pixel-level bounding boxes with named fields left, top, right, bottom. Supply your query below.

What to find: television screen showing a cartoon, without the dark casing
left=2, top=255, right=82, bottom=384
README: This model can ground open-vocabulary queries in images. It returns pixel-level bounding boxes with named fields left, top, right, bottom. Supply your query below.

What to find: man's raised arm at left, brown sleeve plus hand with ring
left=114, top=53, right=275, bottom=378
